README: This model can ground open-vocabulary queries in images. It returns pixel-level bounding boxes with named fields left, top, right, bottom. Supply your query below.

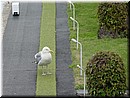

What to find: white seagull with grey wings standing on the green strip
left=34, top=46, right=53, bottom=75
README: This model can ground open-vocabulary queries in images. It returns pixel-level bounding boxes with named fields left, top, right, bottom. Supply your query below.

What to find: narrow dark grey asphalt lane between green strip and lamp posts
left=56, top=2, right=76, bottom=96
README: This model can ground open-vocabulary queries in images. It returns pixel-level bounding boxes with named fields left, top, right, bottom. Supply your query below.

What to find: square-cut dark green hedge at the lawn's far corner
left=97, top=2, right=128, bottom=38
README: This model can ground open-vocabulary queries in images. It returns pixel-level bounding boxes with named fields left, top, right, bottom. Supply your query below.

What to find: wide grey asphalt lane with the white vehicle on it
left=2, top=2, right=42, bottom=96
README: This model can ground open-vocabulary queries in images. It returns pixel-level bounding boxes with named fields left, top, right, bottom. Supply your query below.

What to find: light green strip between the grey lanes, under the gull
left=36, top=2, right=56, bottom=96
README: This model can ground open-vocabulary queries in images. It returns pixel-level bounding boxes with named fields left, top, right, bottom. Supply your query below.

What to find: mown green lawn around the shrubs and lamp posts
left=67, top=2, right=128, bottom=89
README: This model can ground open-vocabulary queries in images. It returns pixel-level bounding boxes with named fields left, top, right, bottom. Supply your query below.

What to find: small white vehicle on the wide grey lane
left=12, top=2, right=20, bottom=16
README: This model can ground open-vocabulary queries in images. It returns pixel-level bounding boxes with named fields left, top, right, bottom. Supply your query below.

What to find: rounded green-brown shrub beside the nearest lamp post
left=86, top=51, right=127, bottom=96
